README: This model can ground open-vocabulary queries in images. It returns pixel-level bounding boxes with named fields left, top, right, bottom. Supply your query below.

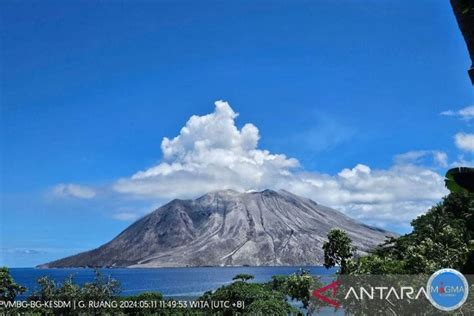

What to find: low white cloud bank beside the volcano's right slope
left=288, top=164, right=447, bottom=226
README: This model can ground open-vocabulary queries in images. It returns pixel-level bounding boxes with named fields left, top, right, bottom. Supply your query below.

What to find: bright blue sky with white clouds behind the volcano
left=0, top=0, right=474, bottom=266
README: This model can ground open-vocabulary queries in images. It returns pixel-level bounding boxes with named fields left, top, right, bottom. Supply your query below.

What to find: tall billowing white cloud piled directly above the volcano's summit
left=114, top=101, right=299, bottom=198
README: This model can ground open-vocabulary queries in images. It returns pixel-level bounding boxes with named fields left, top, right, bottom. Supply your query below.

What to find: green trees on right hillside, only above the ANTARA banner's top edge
left=324, top=190, right=474, bottom=274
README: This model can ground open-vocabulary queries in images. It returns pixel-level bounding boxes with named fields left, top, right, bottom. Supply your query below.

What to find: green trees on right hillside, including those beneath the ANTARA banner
left=324, top=188, right=474, bottom=315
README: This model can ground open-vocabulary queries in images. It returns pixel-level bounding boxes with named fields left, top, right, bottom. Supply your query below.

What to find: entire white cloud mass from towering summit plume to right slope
left=114, top=101, right=447, bottom=225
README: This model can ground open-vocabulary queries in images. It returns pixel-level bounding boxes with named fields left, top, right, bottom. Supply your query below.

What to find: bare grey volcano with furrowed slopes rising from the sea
left=40, top=190, right=395, bottom=268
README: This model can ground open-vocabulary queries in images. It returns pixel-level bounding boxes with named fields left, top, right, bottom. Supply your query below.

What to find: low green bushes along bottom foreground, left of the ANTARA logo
left=0, top=268, right=326, bottom=315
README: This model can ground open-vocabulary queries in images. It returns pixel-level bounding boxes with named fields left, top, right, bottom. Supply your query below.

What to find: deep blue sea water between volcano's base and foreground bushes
left=10, top=266, right=337, bottom=299
